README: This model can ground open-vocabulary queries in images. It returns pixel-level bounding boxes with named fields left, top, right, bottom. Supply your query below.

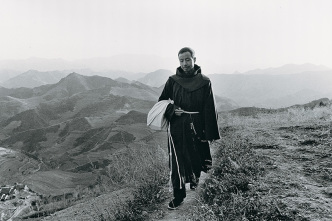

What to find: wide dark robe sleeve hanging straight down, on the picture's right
left=203, top=82, right=220, bottom=141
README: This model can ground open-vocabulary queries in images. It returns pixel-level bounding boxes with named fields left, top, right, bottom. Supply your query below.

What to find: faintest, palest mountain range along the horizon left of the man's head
left=0, top=54, right=177, bottom=73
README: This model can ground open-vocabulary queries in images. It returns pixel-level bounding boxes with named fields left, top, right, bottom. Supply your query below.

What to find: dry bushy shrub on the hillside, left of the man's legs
left=100, top=145, right=168, bottom=220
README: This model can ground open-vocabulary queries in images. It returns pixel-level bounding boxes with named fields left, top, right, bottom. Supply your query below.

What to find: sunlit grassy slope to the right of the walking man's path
left=191, top=108, right=332, bottom=220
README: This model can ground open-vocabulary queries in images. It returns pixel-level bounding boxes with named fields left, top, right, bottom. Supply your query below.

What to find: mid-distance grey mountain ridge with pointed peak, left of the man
left=0, top=73, right=158, bottom=120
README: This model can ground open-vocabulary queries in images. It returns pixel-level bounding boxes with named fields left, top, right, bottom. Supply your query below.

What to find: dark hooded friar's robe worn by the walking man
left=159, top=65, right=220, bottom=192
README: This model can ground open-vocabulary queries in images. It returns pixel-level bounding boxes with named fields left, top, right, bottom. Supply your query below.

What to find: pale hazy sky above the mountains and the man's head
left=0, top=0, right=332, bottom=73
